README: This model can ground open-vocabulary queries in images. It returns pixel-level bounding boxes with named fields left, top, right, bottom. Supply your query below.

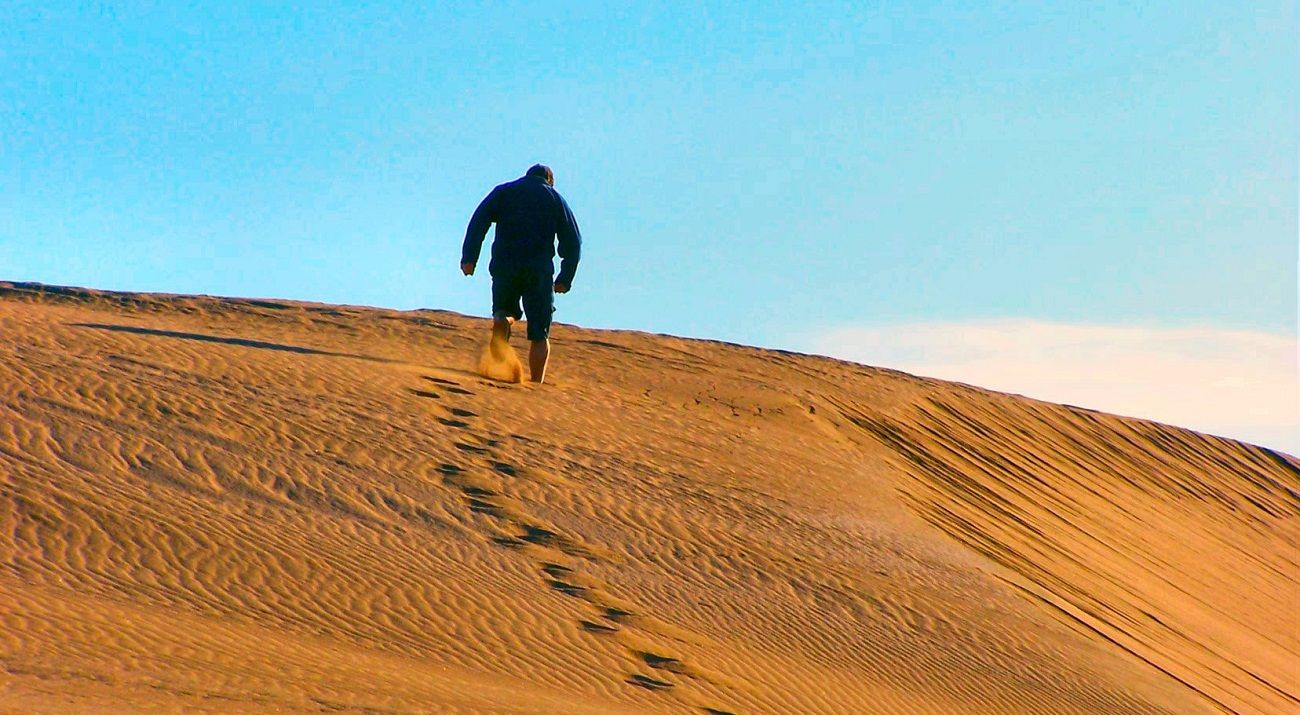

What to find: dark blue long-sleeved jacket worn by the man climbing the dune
left=460, top=177, right=582, bottom=285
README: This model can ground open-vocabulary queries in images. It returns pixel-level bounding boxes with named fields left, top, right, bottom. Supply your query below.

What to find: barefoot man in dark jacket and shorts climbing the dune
left=460, top=164, right=582, bottom=382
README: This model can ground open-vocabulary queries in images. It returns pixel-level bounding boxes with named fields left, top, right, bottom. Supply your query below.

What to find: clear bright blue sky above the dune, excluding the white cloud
left=0, top=0, right=1300, bottom=452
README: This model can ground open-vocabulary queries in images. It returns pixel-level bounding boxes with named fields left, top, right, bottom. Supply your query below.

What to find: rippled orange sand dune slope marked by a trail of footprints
left=0, top=283, right=1300, bottom=715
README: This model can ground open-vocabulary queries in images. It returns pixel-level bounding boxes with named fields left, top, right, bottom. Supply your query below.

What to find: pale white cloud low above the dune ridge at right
left=806, top=320, right=1300, bottom=454
